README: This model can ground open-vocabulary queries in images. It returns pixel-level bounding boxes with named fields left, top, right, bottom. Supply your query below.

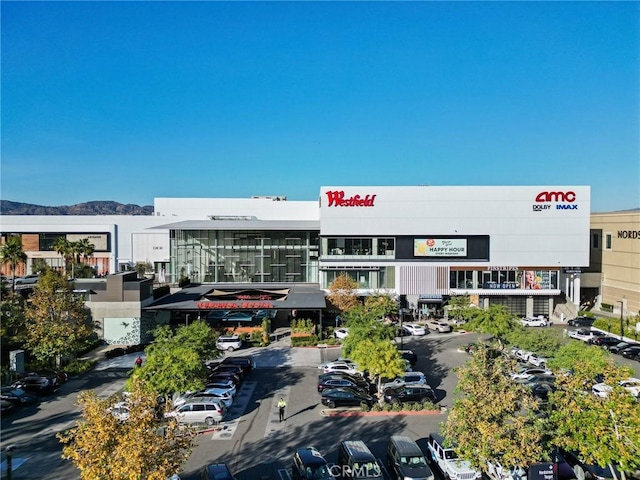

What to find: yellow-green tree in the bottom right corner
left=549, top=358, right=640, bottom=478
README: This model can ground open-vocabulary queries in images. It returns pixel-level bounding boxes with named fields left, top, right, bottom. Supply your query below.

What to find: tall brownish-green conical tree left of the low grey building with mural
left=25, top=270, right=92, bottom=364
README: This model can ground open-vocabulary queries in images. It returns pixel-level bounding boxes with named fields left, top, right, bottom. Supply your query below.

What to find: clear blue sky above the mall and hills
left=0, top=1, right=640, bottom=211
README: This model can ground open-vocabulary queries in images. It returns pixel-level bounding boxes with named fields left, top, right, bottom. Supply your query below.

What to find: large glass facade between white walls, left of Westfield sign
left=167, top=230, right=318, bottom=283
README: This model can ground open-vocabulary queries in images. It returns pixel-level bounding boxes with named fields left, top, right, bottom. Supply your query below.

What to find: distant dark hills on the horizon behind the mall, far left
left=0, top=200, right=153, bottom=215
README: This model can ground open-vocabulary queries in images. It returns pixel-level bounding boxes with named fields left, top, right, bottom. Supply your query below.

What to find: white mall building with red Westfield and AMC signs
left=0, top=185, right=591, bottom=317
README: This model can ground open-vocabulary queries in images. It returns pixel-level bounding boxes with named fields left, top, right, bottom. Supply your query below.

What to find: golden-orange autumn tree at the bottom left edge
left=58, top=381, right=194, bottom=480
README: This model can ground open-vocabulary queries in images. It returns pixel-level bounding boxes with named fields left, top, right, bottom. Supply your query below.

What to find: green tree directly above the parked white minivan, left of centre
left=129, top=320, right=220, bottom=398
